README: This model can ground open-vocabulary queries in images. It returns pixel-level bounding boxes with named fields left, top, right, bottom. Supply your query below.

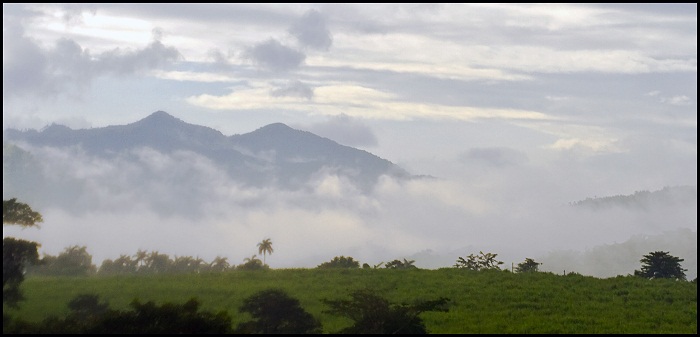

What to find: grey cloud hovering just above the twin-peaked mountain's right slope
left=306, top=114, right=377, bottom=147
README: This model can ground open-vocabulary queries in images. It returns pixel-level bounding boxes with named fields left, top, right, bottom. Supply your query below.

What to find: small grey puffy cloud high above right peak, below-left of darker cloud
left=247, top=39, right=306, bottom=72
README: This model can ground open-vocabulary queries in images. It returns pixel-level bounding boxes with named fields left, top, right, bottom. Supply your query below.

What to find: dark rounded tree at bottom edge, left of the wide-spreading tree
left=235, top=289, right=321, bottom=334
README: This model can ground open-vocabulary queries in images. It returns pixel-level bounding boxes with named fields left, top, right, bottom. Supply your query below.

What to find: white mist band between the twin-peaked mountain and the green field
left=3, top=144, right=697, bottom=279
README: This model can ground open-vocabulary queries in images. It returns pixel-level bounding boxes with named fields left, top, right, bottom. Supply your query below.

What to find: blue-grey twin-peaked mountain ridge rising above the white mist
left=3, top=111, right=411, bottom=194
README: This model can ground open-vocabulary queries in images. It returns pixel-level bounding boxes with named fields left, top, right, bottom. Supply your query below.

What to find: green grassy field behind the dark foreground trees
left=5, top=268, right=697, bottom=334
